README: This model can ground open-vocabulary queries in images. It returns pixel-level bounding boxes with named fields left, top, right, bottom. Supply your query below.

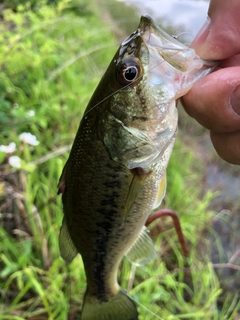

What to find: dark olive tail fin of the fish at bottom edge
left=81, top=290, right=138, bottom=320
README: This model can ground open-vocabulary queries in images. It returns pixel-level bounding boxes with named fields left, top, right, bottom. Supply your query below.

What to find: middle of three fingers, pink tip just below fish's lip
left=182, top=67, right=240, bottom=133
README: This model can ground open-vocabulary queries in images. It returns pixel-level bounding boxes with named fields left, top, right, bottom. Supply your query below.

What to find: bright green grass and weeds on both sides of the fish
left=0, top=0, right=240, bottom=320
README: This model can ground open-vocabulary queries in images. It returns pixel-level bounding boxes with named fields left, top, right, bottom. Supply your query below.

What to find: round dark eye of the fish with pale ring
left=117, top=60, right=141, bottom=86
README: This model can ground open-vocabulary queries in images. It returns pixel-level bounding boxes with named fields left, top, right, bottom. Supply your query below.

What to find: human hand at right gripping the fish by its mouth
left=182, top=0, right=240, bottom=165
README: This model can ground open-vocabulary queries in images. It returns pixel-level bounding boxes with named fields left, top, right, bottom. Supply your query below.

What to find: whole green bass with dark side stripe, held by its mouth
left=58, top=15, right=215, bottom=320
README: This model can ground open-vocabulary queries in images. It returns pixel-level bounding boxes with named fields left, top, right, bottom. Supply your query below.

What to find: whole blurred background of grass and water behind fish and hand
left=0, top=0, right=240, bottom=320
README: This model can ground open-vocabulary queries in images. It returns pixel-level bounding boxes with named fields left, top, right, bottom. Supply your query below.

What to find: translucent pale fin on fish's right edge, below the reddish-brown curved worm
left=125, top=227, right=156, bottom=266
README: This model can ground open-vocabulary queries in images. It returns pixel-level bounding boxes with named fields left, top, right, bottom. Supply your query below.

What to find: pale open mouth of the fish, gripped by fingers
left=138, top=15, right=216, bottom=92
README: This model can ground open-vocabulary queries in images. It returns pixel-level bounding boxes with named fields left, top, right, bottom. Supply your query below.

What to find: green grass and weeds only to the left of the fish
left=0, top=1, right=115, bottom=320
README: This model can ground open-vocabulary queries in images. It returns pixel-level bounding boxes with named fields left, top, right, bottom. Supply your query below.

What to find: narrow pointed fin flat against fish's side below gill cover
left=124, top=168, right=151, bottom=220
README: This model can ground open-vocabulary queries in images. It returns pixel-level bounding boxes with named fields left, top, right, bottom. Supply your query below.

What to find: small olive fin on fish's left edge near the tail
left=59, top=218, right=78, bottom=263
